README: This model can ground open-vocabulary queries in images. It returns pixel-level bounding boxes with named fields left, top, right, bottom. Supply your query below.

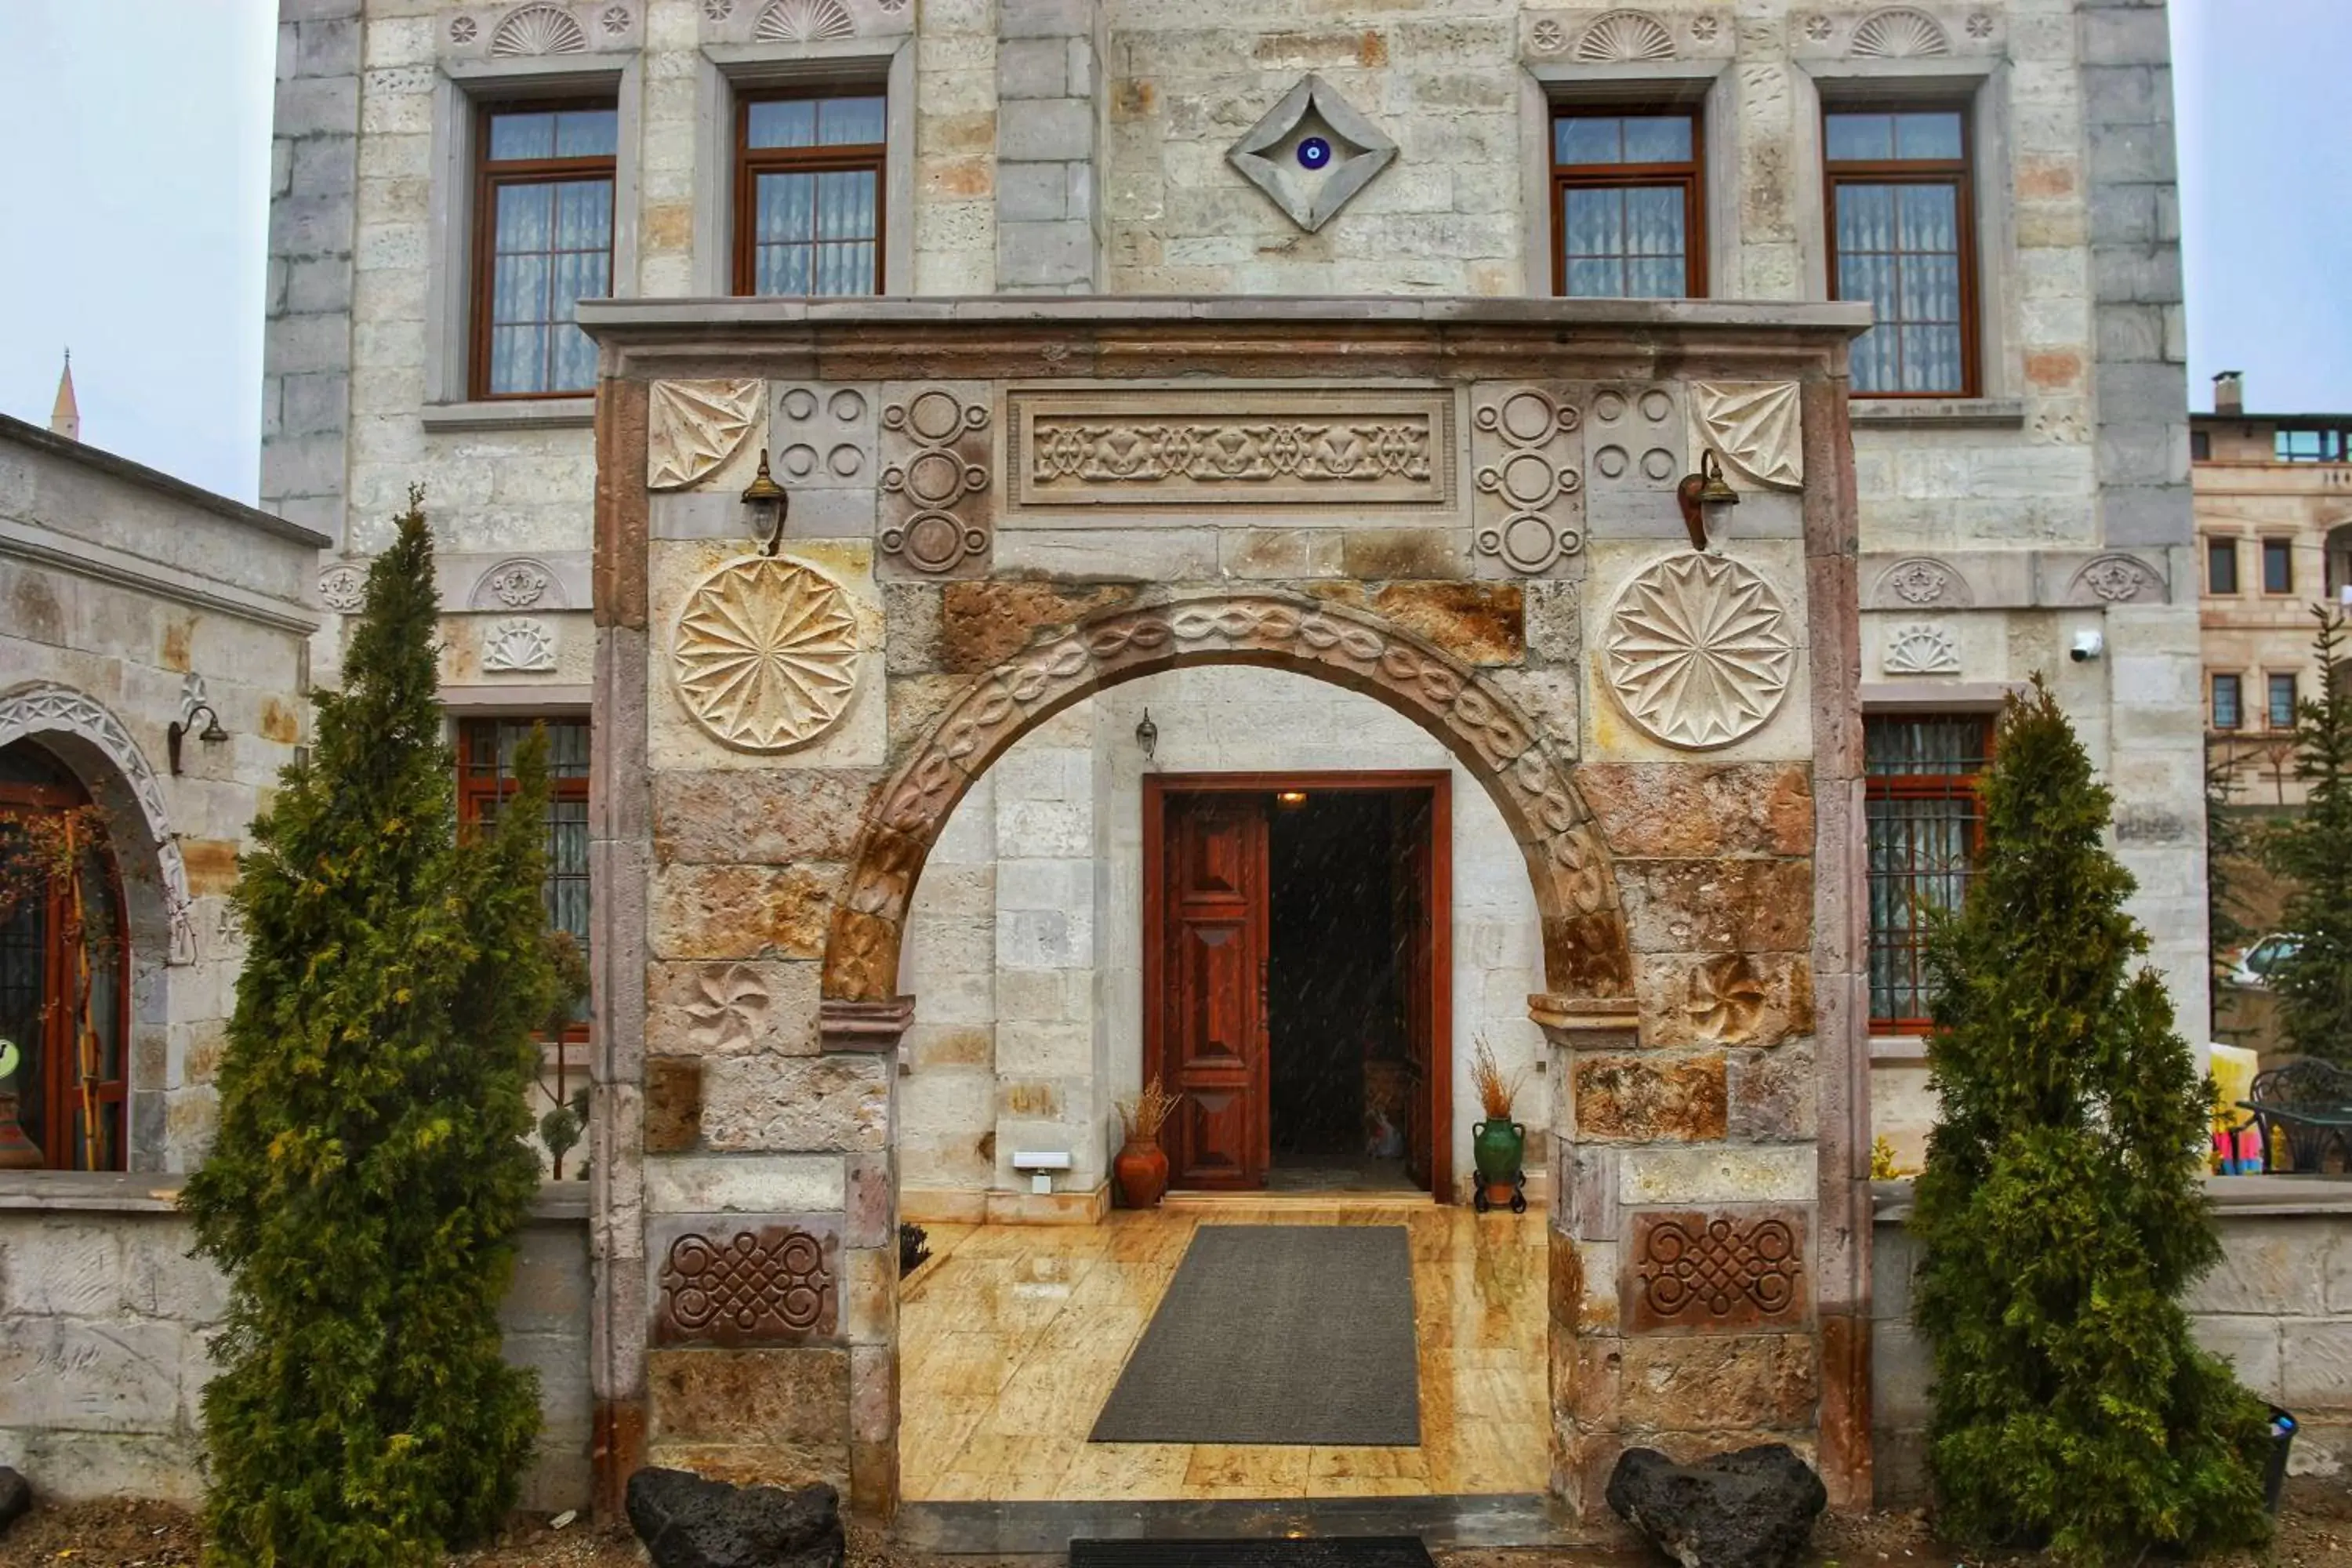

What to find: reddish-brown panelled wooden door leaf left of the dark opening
left=1143, top=794, right=1268, bottom=1189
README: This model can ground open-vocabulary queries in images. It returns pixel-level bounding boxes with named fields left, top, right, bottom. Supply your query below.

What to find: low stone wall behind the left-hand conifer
left=0, top=1173, right=588, bottom=1512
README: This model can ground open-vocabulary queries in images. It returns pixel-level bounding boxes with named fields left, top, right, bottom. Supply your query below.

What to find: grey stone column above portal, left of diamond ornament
left=997, top=0, right=1103, bottom=294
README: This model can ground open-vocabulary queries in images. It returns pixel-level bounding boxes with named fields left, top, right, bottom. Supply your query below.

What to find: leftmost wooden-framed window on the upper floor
left=468, top=99, right=621, bottom=397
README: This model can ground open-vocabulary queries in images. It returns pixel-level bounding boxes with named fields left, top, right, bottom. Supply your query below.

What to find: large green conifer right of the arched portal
left=1910, top=682, right=2267, bottom=1563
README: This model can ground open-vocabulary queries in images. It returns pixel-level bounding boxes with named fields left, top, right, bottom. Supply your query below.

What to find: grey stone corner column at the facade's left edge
left=261, top=0, right=365, bottom=552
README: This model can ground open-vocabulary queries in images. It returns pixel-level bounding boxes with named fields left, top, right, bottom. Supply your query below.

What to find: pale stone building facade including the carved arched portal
left=263, top=0, right=2204, bottom=1507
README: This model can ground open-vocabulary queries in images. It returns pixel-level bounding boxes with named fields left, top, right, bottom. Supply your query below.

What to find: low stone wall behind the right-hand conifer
left=1870, top=1175, right=2352, bottom=1507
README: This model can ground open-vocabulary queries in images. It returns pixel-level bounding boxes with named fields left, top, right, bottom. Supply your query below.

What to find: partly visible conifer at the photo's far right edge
left=2263, top=604, right=2352, bottom=1062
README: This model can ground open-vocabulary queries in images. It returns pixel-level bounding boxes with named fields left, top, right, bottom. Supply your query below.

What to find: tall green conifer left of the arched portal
left=183, top=492, right=553, bottom=1568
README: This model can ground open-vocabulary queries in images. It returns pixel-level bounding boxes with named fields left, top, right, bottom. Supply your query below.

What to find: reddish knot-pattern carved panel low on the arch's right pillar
left=1623, top=1213, right=1806, bottom=1333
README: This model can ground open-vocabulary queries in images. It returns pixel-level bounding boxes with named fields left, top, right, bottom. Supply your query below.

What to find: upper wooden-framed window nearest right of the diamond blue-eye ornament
left=1552, top=108, right=1708, bottom=299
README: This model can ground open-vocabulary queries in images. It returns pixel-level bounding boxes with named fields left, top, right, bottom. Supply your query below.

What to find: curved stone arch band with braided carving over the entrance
left=823, top=593, right=1632, bottom=1001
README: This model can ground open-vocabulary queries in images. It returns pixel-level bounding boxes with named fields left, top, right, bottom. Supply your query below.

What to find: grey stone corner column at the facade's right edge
left=2077, top=0, right=2209, bottom=1039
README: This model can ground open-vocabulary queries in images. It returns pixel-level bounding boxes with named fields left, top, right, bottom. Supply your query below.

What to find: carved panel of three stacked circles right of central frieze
left=1470, top=386, right=1585, bottom=576
